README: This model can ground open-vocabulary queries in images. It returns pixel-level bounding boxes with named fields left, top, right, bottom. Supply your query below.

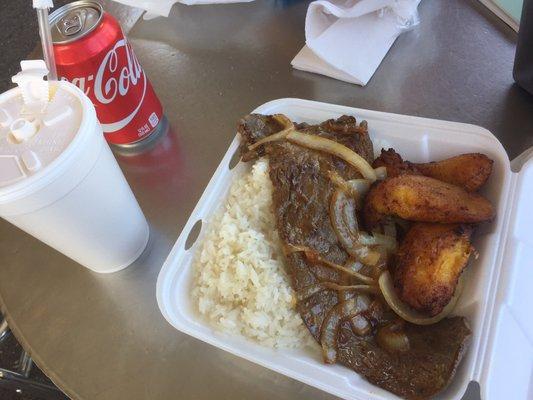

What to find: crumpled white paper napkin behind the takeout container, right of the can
left=291, top=0, right=420, bottom=86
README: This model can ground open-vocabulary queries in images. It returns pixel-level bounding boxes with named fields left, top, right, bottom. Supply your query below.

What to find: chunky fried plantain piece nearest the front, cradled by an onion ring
left=391, top=222, right=473, bottom=316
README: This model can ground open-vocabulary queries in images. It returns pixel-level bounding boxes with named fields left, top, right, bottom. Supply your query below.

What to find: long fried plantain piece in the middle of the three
left=363, top=175, right=494, bottom=230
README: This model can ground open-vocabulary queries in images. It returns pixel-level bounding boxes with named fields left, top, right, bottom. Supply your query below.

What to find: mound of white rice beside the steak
left=192, top=159, right=316, bottom=348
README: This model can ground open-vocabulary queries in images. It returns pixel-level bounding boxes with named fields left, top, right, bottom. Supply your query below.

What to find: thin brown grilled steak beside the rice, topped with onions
left=238, top=114, right=470, bottom=399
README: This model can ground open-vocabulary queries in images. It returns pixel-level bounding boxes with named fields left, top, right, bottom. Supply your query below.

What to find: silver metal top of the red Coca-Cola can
left=49, top=0, right=104, bottom=44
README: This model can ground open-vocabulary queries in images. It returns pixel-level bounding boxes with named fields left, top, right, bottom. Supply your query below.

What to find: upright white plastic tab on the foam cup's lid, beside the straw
left=11, top=60, right=50, bottom=115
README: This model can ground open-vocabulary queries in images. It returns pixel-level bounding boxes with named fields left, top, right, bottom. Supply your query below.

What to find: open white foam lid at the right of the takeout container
left=480, top=148, right=533, bottom=400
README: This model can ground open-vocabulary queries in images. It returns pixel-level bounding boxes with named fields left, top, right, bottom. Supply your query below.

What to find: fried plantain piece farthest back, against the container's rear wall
left=373, top=149, right=493, bottom=192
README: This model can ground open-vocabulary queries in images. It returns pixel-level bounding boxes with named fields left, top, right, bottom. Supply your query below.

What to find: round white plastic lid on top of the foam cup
left=0, top=60, right=83, bottom=190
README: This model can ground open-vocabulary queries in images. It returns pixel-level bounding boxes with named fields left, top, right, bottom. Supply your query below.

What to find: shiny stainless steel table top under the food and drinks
left=0, top=0, right=533, bottom=400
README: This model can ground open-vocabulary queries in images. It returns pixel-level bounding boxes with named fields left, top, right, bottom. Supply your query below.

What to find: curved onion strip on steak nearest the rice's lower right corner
left=320, top=296, right=366, bottom=364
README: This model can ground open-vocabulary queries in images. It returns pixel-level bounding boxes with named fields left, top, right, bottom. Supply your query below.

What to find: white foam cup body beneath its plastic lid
left=0, top=82, right=149, bottom=273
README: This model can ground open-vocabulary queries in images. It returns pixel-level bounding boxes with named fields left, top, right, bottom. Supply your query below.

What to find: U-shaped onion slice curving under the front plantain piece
left=379, top=271, right=463, bottom=325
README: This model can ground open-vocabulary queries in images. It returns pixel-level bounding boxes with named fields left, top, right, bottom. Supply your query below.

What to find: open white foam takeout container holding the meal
left=157, top=99, right=533, bottom=400
